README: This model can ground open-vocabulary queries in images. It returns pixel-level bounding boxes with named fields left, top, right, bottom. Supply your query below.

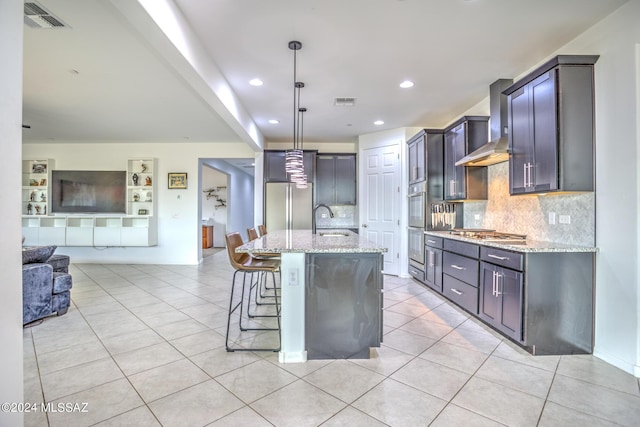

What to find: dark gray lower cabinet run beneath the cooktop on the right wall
left=425, top=235, right=595, bottom=355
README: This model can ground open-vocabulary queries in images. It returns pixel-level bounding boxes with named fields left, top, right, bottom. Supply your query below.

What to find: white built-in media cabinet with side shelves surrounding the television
left=22, top=158, right=158, bottom=247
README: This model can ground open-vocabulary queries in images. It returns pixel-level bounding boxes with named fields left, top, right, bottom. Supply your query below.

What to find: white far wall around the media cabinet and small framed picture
left=24, top=142, right=254, bottom=264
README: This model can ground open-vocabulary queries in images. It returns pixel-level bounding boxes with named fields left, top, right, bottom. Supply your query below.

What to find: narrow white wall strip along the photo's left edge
left=0, top=1, right=23, bottom=427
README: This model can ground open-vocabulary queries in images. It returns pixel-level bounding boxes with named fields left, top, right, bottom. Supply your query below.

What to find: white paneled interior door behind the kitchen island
left=360, top=144, right=402, bottom=275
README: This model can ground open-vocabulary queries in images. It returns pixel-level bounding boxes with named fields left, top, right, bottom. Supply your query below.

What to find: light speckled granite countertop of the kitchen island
left=236, top=230, right=387, bottom=254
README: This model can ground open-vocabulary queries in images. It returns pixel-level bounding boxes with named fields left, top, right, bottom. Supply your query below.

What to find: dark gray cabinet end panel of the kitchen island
left=305, top=253, right=382, bottom=359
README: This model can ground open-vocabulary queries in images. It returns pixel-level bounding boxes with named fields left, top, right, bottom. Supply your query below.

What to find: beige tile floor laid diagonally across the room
left=24, top=251, right=640, bottom=427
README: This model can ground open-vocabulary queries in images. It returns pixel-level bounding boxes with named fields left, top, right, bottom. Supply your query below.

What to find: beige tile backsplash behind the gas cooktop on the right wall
left=464, top=162, right=595, bottom=246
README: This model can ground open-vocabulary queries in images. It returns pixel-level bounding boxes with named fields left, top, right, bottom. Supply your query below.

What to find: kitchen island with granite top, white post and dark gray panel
left=236, top=230, right=387, bottom=363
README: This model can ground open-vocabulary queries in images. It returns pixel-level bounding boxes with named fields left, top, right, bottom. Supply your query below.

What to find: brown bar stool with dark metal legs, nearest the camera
left=225, top=232, right=280, bottom=352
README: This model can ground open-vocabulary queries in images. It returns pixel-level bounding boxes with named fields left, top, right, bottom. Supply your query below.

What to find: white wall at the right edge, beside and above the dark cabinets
left=558, top=0, right=640, bottom=377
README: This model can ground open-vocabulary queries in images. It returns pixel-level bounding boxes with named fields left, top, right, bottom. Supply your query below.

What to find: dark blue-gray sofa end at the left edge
left=22, top=246, right=72, bottom=325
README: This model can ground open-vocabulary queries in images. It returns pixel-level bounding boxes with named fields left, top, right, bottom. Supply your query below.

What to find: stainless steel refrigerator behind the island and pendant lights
left=264, top=182, right=313, bottom=230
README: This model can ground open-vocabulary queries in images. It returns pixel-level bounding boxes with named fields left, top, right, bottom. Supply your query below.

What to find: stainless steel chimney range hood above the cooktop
left=456, top=79, right=513, bottom=166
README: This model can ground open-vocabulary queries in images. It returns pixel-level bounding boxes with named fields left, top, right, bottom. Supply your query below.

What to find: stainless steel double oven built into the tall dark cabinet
left=408, top=182, right=427, bottom=281
